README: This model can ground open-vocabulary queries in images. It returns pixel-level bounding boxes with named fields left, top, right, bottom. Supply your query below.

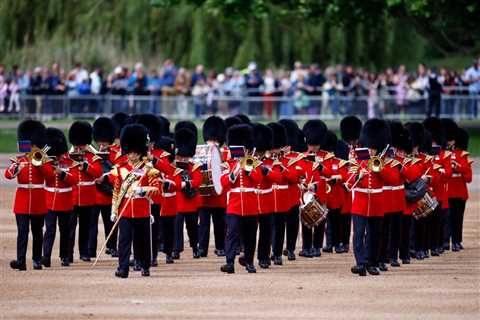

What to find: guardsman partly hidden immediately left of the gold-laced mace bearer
left=88, top=117, right=119, bottom=257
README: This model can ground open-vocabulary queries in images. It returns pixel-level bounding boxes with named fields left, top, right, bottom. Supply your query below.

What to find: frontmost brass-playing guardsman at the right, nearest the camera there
left=347, top=119, right=390, bottom=276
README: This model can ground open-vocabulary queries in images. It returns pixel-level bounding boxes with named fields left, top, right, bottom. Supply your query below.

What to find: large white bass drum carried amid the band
left=193, top=144, right=222, bottom=196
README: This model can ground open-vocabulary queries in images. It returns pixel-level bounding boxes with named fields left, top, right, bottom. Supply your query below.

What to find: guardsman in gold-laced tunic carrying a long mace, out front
left=111, top=124, right=160, bottom=278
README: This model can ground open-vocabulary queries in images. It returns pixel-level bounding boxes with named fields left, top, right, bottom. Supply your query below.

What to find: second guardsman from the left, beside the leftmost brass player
left=42, top=128, right=79, bottom=268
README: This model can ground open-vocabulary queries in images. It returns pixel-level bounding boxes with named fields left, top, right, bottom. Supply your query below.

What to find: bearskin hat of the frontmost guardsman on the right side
left=359, top=119, right=390, bottom=152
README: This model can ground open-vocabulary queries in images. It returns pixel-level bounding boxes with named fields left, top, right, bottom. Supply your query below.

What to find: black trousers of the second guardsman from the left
left=43, top=210, right=72, bottom=259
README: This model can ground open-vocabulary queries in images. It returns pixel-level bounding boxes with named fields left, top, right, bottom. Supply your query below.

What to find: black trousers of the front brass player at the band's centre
left=225, top=214, right=257, bottom=264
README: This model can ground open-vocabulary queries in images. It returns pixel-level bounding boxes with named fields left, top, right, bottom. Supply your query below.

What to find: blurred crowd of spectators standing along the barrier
left=0, top=58, right=480, bottom=118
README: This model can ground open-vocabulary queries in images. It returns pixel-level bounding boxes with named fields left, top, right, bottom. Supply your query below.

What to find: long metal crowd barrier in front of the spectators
left=0, top=94, right=480, bottom=120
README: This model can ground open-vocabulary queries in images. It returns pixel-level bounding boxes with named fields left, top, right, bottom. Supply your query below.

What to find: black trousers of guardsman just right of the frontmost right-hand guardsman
left=380, top=212, right=402, bottom=263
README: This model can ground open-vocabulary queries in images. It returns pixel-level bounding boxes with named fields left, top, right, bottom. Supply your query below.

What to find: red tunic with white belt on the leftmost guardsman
left=5, top=156, right=54, bottom=214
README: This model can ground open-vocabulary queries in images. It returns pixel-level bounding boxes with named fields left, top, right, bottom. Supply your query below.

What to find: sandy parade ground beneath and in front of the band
left=0, top=160, right=480, bottom=319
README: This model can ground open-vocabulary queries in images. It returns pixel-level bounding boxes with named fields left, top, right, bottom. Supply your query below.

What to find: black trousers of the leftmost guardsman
left=15, top=214, right=45, bottom=263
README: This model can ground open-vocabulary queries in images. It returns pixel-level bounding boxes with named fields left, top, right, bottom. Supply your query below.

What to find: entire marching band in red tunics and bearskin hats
left=5, top=113, right=472, bottom=278
